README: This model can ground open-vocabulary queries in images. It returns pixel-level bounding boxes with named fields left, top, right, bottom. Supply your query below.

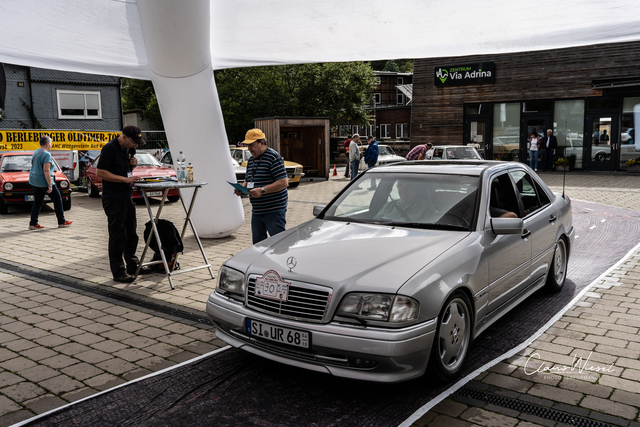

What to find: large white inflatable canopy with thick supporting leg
left=0, top=0, right=640, bottom=237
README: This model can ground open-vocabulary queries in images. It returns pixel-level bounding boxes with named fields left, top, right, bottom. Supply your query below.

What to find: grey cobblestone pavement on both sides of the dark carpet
left=0, top=171, right=640, bottom=426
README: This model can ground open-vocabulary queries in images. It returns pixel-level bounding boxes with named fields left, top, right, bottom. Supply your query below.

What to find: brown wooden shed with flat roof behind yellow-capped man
left=254, top=117, right=331, bottom=179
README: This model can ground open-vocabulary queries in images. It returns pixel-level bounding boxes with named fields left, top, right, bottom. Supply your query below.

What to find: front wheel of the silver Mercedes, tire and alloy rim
left=429, top=292, right=472, bottom=381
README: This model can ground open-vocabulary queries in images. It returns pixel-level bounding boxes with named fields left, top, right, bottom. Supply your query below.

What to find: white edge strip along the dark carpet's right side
left=399, top=244, right=640, bottom=427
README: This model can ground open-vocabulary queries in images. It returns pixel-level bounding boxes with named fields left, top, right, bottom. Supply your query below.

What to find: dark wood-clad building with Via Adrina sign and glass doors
left=410, top=42, right=640, bottom=170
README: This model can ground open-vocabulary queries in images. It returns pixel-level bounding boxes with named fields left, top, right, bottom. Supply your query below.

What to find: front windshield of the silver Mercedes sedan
left=324, top=173, right=478, bottom=230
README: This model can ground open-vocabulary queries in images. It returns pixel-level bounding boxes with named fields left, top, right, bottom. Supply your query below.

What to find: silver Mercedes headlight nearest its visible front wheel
left=336, top=293, right=420, bottom=323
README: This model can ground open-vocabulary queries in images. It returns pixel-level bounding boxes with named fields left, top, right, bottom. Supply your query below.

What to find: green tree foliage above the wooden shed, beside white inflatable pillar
left=215, top=62, right=376, bottom=144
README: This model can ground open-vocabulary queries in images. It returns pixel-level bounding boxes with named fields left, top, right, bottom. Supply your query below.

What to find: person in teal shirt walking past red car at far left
left=29, top=135, right=73, bottom=230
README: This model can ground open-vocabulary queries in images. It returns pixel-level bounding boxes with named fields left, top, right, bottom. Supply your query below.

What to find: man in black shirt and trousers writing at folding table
left=96, top=126, right=145, bottom=283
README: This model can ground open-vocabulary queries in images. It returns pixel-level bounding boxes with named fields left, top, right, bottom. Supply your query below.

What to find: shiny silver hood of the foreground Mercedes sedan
left=238, top=219, right=469, bottom=292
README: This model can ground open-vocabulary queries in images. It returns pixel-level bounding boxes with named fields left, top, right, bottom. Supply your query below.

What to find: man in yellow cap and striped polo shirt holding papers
left=235, top=129, right=289, bottom=245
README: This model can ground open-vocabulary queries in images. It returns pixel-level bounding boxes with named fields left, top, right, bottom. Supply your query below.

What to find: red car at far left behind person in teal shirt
left=0, top=152, right=71, bottom=214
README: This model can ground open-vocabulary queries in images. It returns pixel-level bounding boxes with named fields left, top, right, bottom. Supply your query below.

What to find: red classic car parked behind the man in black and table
left=87, top=153, right=180, bottom=203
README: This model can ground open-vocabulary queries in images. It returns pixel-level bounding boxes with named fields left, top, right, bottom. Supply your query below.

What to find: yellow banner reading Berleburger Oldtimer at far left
left=0, top=129, right=116, bottom=151
